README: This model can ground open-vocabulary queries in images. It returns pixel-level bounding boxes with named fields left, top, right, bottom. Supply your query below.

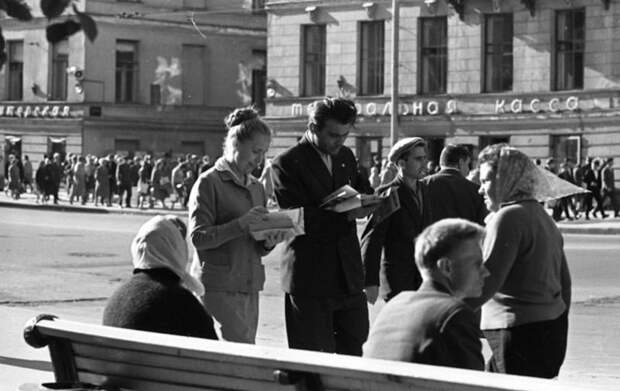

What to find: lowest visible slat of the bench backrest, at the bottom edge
left=75, top=357, right=294, bottom=391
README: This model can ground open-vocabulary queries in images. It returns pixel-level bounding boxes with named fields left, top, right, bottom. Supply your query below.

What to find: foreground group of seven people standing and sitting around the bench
left=66, top=98, right=612, bottom=378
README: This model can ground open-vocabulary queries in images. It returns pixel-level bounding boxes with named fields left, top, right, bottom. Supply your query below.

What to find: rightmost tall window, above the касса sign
left=554, top=9, right=586, bottom=90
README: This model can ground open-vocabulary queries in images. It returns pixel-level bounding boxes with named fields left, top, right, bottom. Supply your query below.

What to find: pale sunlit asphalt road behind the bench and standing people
left=0, top=208, right=620, bottom=387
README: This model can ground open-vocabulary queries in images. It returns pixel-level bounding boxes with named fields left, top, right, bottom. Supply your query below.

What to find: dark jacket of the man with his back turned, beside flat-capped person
left=422, top=168, right=489, bottom=225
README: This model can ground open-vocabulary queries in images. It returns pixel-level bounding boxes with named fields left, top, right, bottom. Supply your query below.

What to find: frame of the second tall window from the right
left=481, top=13, right=514, bottom=93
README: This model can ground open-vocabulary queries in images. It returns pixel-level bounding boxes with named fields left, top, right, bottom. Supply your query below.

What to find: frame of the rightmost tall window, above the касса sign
left=551, top=7, right=587, bottom=91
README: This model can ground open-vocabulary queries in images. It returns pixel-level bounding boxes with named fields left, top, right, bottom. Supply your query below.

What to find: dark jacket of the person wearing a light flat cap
left=361, top=176, right=431, bottom=300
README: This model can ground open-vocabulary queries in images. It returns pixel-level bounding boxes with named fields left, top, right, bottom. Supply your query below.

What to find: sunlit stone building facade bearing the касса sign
left=266, top=0, right=620, bottom=184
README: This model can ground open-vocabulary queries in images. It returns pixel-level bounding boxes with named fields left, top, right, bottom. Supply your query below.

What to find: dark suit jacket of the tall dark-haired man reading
left=272, top=137, right=372, bottom=297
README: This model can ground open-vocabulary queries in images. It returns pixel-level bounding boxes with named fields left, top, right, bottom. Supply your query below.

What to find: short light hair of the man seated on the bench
left=415, top=218, right=484, bottom=270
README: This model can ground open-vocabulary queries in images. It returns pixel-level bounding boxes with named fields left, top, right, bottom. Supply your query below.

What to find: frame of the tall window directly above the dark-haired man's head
left=299, top=24, right=327, bottom=96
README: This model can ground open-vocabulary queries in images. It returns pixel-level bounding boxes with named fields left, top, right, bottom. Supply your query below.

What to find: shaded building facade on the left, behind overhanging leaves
left=0, top=0, right=266, bottom=167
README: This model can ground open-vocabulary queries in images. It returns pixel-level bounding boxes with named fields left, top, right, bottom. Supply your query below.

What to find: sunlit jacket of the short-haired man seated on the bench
left=364, top=282, right=484, bottom=370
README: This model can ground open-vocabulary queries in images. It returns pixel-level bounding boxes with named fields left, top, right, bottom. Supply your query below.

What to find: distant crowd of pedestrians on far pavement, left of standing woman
left=0, top=153, right=213, bottom=209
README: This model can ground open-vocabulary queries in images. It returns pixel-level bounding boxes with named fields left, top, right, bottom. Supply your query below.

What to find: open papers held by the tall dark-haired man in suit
left=321, top=185, right=400, bottom=220
